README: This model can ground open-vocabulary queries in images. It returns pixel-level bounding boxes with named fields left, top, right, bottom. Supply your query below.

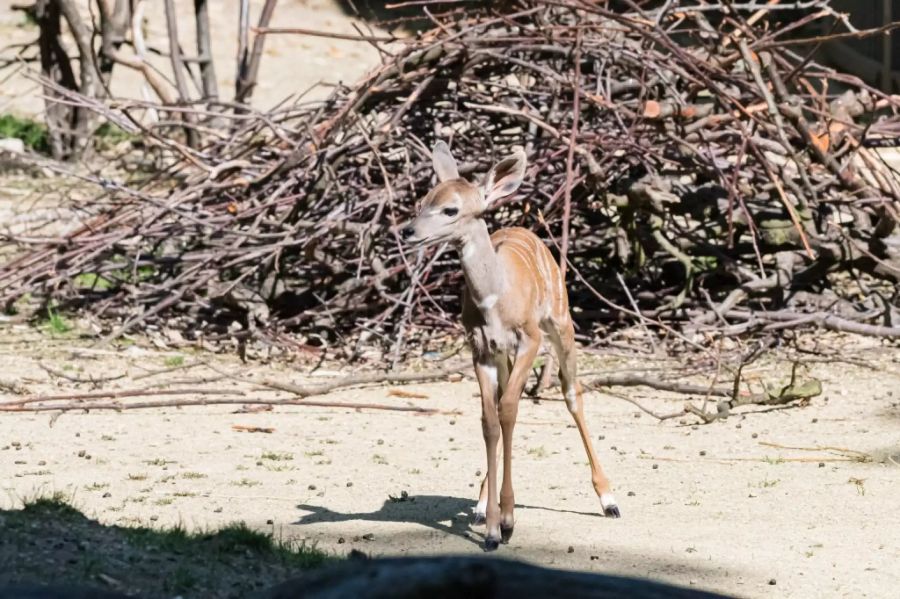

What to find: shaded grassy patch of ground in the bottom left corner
left=0, top=497, right=329, bottom=599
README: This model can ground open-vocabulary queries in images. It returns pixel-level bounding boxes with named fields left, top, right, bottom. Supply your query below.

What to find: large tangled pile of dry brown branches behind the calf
left=0, top=0, right=900, bottom=358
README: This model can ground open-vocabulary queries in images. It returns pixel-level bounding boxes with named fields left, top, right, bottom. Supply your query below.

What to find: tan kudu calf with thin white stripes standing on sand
left=401, top=141, right=619, bottom=550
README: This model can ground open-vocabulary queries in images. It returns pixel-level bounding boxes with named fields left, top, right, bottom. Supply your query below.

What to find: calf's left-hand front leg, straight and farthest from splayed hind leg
left=475, top=357, right=500, bottom=551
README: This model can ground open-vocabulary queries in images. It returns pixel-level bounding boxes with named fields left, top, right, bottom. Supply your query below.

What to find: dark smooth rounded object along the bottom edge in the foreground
left=259, top=557, right=725, bottom=599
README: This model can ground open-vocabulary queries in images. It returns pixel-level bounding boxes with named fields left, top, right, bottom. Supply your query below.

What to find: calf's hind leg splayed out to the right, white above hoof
left=550, top=320, right=621, bottom=518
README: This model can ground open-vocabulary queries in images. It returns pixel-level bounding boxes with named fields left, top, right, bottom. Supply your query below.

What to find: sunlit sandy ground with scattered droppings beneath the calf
left=0, top=326, right=900, bottom=597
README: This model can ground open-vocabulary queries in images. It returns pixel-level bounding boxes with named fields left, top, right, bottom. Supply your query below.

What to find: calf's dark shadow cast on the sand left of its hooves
left=294, top=495, right=481, bottom=544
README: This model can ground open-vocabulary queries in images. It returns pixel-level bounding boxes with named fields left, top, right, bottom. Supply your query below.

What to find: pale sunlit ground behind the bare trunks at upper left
left=0, top=0, right=383, bottom=115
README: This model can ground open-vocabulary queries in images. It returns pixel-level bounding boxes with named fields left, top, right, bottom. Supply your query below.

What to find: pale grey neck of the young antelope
left=458, top=218, right=505, bottom=312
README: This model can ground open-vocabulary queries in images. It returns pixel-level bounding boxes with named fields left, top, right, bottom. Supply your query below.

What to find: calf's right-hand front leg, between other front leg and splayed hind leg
left=500, top=331, right=541, bottom=543
